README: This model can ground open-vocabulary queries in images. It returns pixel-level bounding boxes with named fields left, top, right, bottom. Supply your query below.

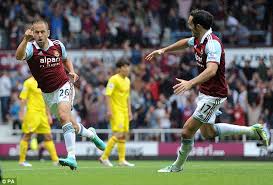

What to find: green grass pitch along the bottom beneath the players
left=1, top=161, right=273, bottom=185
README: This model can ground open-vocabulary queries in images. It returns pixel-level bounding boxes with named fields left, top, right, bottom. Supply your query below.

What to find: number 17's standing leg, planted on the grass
left=158, top=116, right=202, bottom=173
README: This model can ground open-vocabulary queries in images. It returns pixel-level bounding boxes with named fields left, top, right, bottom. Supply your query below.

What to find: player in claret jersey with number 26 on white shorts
left=16, top=20, right=105, bottom=170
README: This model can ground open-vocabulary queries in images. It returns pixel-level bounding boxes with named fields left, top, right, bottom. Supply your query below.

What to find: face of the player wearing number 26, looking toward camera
left=33, top=22, right=49, bottom=48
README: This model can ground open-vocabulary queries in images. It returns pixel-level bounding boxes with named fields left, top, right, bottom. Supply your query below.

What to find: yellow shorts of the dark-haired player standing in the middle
left=110, top=112, right=129, bottom=132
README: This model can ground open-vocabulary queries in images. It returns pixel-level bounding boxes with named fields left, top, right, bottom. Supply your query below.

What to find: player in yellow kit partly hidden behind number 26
left=19, top=77, right=58, bottom=167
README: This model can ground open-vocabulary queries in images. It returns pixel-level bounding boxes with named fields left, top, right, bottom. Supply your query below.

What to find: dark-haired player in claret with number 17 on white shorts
left=145, top=10, right=268, bottom=172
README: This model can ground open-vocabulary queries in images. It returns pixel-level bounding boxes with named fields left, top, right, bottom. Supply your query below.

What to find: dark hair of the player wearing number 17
left=190, top=9, right=213, bottom=30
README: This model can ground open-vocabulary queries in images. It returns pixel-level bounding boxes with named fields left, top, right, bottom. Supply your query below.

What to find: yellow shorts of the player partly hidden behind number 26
left=22, top=111, right=51, bottom=134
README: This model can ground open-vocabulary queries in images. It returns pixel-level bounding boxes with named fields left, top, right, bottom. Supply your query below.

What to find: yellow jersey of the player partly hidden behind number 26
left=19, top=77, right=46, bottom=112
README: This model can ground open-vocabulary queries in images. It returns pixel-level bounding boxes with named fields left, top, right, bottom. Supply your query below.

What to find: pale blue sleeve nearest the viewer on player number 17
left=205, top=40, right=222, bottom=64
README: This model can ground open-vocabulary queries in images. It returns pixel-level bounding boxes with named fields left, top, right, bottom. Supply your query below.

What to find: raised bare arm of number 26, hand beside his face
left=15, top=29, right=33, bottom=60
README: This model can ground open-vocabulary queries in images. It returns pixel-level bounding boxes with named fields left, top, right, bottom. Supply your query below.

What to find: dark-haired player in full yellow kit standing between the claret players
left=99, top=60, right=135, bottom=167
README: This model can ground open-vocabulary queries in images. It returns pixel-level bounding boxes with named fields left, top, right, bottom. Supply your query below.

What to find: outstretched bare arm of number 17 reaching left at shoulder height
left=145, top=38, right=189, bottom=61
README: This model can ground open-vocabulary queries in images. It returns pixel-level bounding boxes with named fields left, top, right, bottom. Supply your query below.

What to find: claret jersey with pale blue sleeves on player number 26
left=25, top=39, right=69, bottom=93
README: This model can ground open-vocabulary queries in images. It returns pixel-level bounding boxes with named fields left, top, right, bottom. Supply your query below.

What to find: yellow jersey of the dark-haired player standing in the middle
left=105, top=74, right=130, bottom=112
